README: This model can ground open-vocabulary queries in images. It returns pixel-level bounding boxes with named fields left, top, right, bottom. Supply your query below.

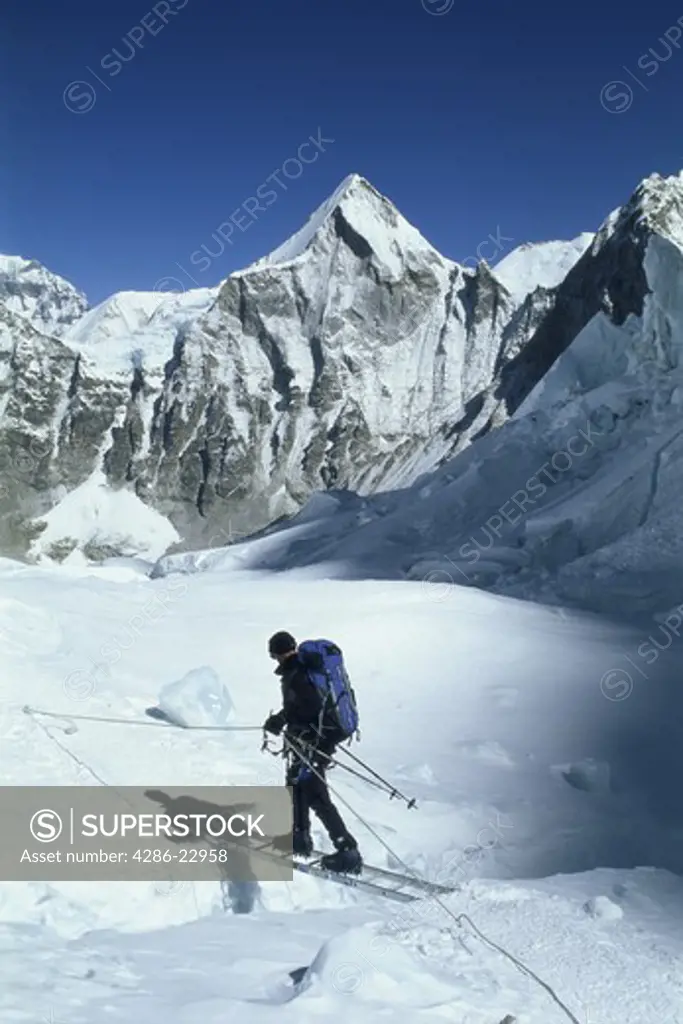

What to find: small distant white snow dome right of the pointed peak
left=493, top=231, right=595, bottom=302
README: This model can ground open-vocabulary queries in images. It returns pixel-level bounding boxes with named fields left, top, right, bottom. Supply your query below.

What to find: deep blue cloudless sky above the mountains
left=5, top=0, right=683, bottom=303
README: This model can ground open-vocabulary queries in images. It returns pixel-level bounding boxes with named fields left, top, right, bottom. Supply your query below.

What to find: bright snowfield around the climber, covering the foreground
left=0, top=552, right=683, bottom=1024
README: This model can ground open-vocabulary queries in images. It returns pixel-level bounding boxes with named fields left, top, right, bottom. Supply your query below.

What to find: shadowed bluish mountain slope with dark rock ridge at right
left=158, top=169, right=683, bottom=614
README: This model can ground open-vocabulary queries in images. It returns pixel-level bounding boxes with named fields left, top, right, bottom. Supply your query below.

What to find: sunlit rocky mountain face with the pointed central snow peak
left=0, top=175, right=547, bottom=558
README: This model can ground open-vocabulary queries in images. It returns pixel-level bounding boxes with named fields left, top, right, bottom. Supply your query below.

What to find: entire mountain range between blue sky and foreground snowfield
left=5, top=167, right=683, bottom=611
